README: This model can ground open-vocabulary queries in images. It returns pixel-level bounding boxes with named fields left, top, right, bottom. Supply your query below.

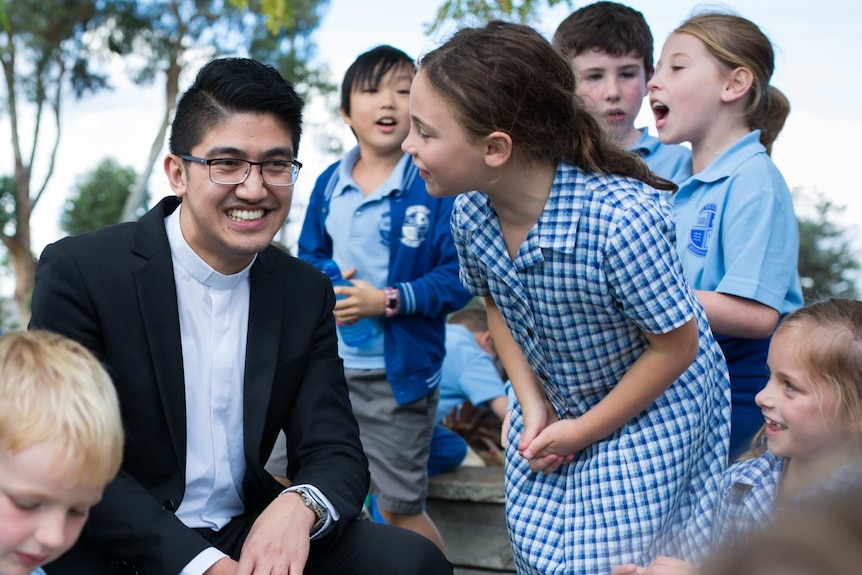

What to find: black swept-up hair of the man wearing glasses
left=169, top=58, right=304, bottom=156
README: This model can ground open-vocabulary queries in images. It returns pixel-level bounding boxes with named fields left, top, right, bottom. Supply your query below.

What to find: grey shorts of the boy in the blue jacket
left=344, top=369, right=439, bottom=515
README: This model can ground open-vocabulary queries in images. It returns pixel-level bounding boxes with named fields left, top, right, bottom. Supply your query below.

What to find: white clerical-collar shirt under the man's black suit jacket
left=165, top=205, right=254, bottom=575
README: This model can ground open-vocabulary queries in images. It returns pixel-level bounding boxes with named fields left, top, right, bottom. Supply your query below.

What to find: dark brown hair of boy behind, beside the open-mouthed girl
left=554, top=2, right=653, bottom=78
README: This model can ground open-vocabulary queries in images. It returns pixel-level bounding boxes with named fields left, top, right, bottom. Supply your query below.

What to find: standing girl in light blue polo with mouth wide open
left=649, top=12, right=802, bottom=459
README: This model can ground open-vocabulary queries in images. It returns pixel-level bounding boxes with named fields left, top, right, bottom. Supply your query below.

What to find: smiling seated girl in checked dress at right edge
left=612, top=299, right=862, bottom=575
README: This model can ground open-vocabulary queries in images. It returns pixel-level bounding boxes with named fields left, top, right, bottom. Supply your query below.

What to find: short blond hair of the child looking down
left=0, top=331, right=123, bottom=485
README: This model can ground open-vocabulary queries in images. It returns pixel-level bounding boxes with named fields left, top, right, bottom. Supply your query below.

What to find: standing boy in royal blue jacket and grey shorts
left=299, top=46, right=470, bottom=549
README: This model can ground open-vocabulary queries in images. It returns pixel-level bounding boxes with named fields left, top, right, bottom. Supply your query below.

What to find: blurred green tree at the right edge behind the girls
left=793, top=188, right=860, bottom=303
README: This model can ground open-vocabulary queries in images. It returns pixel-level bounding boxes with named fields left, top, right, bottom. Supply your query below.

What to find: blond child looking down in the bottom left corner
left=0, top=331, right=123, bottom=575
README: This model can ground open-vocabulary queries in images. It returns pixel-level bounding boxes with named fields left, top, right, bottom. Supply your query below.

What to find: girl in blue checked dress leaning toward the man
left=403, top=22, right=730, bottom=575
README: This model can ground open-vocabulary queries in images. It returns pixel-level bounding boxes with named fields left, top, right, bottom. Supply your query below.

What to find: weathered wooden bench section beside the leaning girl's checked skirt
left=427, top=466, right=515, bottom=575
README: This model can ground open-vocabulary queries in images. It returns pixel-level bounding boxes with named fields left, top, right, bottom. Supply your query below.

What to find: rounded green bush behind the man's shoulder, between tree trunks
left=60, top=158, right=148, bottom=235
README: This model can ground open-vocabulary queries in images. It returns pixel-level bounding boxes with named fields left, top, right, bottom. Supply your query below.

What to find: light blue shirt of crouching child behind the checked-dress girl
left=437, top=323, right=506, bottom=423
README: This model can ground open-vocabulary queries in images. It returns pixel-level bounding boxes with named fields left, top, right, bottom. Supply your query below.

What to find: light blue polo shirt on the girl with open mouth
left=673, top=130, right=802, bottom=314
